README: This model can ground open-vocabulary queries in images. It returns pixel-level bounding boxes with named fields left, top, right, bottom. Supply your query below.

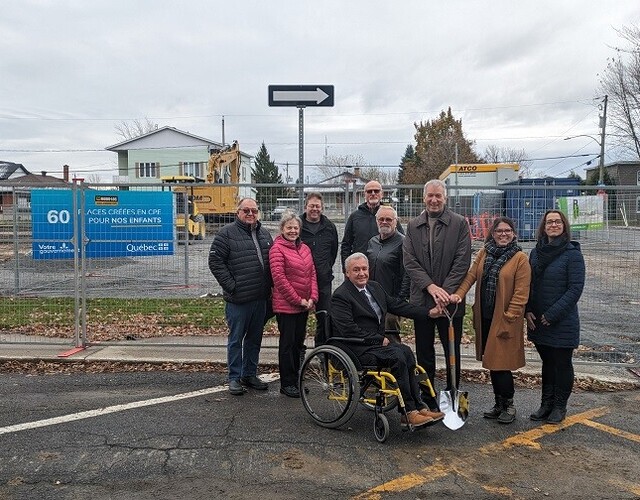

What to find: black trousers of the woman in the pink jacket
left=276, top=311, right=309, bottom=387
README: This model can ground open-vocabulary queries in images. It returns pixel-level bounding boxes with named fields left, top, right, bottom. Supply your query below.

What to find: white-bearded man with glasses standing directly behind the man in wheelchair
left=366, top=205, right=409, bottom=342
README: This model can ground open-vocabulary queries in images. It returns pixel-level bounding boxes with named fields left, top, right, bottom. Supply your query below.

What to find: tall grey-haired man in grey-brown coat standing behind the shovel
left=403, top=179, right=471, bottom=409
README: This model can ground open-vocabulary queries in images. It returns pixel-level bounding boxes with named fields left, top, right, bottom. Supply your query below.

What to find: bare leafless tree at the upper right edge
left=600, top=26, right=640, bottom=158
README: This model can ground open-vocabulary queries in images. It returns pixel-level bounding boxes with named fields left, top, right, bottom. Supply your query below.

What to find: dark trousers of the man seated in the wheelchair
left=360, top=344, right=424, bottom=411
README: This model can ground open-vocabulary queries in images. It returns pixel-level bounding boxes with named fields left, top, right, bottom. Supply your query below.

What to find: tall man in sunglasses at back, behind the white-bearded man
left=340, top=181, right=404, bottom=271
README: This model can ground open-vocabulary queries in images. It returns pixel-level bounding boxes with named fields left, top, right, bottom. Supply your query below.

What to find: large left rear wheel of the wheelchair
left=300, top=345, right=360, bottom=429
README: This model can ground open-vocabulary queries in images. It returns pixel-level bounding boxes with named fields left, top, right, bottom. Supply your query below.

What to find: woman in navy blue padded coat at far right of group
left=526, top=210, right=585, bottom=424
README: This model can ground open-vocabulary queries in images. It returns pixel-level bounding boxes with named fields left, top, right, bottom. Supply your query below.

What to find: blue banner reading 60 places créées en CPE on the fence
left=31, top=189, right=174, bottom=259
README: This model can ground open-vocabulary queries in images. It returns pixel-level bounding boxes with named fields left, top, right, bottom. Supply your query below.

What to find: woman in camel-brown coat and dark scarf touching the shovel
left=450, top=217, right=531, bottom=424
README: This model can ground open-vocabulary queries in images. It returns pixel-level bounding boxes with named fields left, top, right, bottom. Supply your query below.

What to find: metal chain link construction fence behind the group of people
left=0, top=180, right=640, bottom=365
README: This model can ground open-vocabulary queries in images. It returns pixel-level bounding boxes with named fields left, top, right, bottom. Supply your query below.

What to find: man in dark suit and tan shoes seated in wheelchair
left=331, top=253, right=444, bottom=427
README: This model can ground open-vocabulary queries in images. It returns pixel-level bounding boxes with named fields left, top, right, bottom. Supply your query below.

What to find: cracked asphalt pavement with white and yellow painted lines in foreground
left=0, top=371, right=640, bottom=500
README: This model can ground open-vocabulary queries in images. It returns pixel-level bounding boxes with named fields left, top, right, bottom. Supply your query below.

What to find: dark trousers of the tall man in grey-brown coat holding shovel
left=413, top=316, right=462, bottom=391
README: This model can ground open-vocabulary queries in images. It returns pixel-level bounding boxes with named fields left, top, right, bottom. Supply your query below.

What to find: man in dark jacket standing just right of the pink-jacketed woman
left=300, top=193, right=338, bottom=345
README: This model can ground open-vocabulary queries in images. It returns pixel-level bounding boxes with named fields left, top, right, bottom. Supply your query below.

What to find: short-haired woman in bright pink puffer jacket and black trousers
left=269, top=211, right=318, bottom=398
